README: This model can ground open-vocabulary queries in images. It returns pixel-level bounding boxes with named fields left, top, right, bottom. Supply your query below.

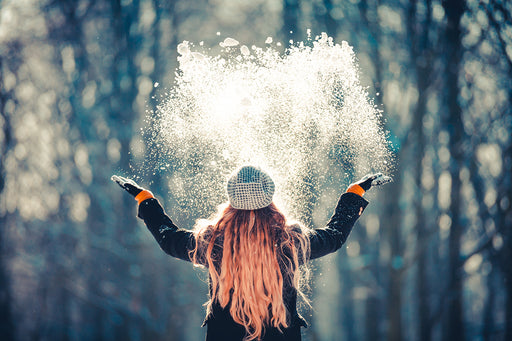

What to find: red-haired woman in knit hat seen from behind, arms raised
left=112, top=166, right=391, bottom=341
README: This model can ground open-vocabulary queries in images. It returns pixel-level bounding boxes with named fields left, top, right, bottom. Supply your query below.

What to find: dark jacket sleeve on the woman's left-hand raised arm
left=138, top=198, right=195, bottom=261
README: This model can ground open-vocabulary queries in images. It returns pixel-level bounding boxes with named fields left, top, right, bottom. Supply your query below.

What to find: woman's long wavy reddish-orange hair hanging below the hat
left=190, top=204, right=309, bottom=340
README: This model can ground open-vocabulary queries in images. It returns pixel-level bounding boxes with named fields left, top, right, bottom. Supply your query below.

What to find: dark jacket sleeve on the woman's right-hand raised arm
left=309, top=193, right=368, bottom=259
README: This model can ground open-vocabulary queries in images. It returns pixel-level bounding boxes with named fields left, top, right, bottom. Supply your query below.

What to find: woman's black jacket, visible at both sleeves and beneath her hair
left=138, top=193, right=368, bottom=341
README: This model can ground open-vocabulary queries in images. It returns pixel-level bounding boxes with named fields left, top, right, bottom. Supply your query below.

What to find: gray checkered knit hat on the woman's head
left=228, top=166, right=275, bottom=210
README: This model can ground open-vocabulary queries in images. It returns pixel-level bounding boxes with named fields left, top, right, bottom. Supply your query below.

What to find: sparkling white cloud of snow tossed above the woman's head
left=144, top=33, right=393, bottom=219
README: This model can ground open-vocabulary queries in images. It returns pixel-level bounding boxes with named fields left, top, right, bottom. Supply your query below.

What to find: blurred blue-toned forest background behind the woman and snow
left=0, top=0, right=512, bottom=341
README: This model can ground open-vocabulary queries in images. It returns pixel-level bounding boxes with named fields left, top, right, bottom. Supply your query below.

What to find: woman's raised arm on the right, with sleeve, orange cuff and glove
left=309, top=173, right=391, bottom=259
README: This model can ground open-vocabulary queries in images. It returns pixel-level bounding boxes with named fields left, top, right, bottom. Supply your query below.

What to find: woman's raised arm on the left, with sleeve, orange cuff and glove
left=112, top=175, right=195, bottom=261
